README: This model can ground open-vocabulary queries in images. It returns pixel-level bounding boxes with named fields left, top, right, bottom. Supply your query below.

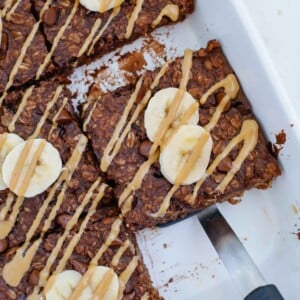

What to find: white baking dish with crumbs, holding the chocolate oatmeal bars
left=72, top=0, right=300, bottom=300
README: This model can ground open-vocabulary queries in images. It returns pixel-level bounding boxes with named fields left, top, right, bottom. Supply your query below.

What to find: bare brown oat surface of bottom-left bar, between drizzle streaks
left=0, top=208, right=161, bottom=300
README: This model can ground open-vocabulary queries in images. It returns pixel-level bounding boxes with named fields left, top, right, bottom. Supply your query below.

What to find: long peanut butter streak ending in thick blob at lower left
left=3, top=135, right=87, bottom=286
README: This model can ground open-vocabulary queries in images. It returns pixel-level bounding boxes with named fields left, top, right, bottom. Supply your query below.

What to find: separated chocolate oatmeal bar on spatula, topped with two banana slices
left=82, top=41, right=280, bottom=229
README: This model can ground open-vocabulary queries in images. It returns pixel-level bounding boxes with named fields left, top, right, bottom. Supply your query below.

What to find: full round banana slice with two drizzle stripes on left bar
left=2, top=139, right=62, bottom=197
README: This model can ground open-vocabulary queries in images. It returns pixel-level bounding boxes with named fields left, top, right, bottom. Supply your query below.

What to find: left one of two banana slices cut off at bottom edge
left=45, top=270, right=93, bottom=300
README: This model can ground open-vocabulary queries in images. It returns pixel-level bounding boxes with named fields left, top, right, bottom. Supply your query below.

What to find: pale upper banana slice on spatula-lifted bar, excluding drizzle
left=144, top=88, right=199, bottom=142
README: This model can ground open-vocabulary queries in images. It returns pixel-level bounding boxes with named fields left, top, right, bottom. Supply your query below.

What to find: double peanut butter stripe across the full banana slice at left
left=9, top=140, right=46, bottom=197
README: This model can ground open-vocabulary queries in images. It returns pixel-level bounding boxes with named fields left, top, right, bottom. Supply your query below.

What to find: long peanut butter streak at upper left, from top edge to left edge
left=0, top=0, right=52, bottom=106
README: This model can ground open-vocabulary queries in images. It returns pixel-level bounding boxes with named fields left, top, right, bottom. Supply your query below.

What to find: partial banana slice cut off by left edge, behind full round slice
left=0, top=133, right=24, bottom=191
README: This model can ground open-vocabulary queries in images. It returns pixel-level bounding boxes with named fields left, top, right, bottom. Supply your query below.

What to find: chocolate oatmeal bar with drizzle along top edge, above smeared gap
left=0, top=0, right=193, bottom=92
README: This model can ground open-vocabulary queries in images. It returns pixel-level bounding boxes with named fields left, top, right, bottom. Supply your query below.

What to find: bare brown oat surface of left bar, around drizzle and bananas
left=0, top=80, right=110, bottom=248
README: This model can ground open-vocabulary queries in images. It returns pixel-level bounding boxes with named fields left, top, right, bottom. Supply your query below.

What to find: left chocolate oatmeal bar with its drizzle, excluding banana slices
left=0, top=80, right=111, bottom=248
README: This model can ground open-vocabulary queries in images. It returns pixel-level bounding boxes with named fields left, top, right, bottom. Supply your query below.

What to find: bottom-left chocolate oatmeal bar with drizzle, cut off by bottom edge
left=0, top=208, right=161, bottom=300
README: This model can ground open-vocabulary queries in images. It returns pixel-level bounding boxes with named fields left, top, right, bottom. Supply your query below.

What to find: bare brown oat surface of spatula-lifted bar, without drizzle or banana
left=83, top=41, right=280, bottom=229
